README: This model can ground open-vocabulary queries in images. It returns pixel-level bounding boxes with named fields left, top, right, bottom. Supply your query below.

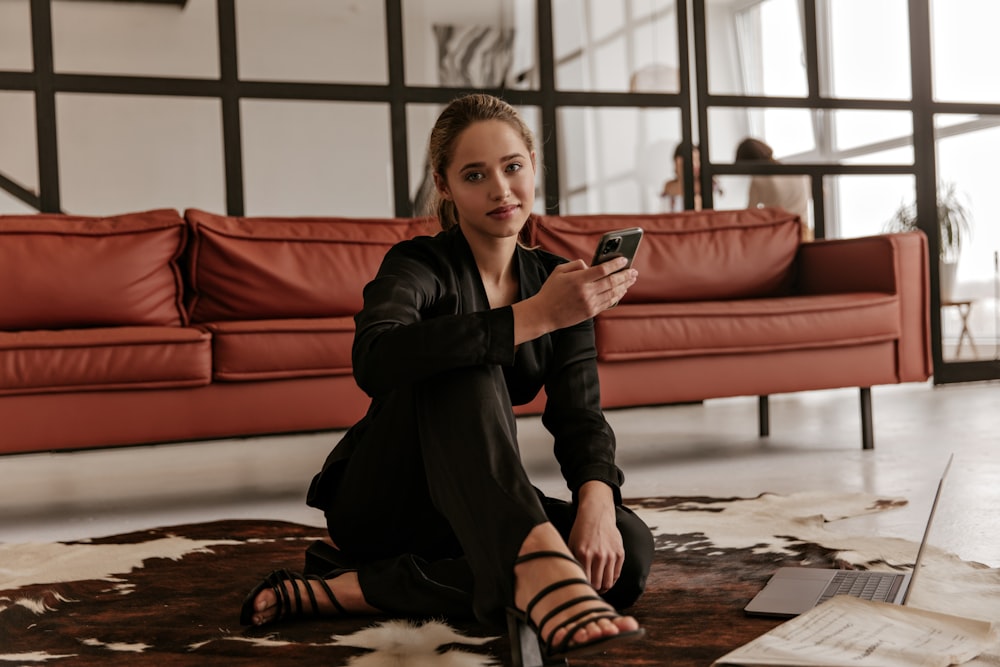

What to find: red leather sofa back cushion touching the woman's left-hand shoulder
left=184, top=209, right=440, bottom=322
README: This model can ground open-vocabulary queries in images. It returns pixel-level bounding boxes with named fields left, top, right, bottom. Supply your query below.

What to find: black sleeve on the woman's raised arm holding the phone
left=351, top=237, right=514, bottom=397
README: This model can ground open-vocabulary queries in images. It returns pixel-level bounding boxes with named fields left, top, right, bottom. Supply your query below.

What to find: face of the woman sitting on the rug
left=434, top=120, right=535, bottom=243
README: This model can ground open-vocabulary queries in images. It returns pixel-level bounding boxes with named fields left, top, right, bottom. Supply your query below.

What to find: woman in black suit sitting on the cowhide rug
left=241, top=95, right=653, bottom=657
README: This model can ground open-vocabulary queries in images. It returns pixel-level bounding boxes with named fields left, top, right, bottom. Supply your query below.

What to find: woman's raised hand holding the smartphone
left=513, top=257, right=639, bottom=345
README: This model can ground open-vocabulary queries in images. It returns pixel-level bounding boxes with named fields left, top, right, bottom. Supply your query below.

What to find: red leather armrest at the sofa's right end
left=796, top=231, right=933, bottom=382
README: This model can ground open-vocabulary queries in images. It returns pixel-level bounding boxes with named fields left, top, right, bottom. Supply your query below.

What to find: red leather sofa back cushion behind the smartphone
left=531, top=208, right=800, bottom=303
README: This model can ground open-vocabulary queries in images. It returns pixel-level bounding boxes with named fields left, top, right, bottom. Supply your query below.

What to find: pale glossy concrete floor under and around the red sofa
left=0, top=382, right=1000, bottom=567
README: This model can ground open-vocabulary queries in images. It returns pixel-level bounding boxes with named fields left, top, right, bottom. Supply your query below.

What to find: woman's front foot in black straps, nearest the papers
left=514, top=523, right=639, bottom=649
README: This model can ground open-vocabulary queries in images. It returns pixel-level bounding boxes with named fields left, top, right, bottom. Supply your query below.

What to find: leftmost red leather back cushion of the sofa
left=0, top=209, right=187, bottom=331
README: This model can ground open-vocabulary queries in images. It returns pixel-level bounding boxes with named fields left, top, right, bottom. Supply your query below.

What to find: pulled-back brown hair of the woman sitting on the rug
left=427, top=93, right=535, bottom=230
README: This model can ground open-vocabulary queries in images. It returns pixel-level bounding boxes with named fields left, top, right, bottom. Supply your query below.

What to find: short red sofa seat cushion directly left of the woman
left=203, top=317, right=354, bottom=381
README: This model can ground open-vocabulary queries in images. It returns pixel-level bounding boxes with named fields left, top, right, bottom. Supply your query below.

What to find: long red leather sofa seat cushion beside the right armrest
left=595, top=292, right=901, bottom=361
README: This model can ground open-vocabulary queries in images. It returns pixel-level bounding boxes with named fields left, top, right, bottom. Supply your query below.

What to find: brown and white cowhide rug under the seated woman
left=0, top=493, right=1000, bottom=667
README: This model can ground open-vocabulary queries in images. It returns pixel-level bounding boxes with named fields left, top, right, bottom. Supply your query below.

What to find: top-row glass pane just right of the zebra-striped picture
left=552, top=0, right=680, bottom=93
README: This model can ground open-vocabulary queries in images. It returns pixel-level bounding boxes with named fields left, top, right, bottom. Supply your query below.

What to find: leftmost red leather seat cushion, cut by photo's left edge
left=0, top=327, right=212, bottom=395
